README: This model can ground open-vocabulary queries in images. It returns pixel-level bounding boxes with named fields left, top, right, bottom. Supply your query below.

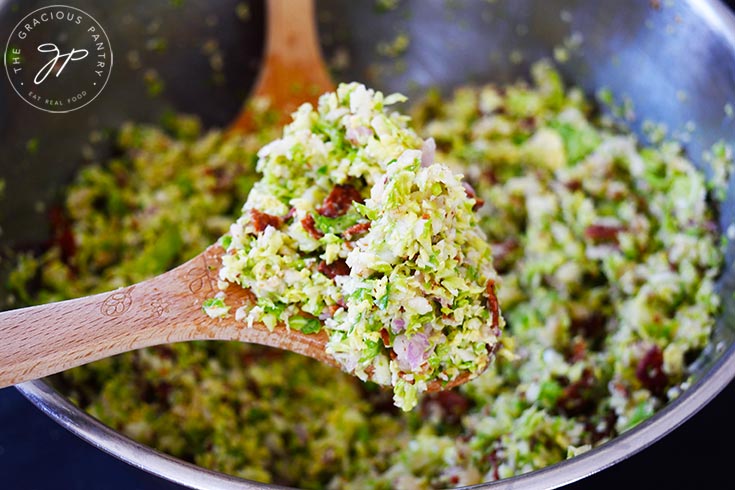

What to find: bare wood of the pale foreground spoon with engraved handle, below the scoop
left=0, top=246, right=334, bottom=387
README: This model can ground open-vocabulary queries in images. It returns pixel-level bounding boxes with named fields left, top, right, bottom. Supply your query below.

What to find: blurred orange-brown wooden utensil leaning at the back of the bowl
left=231, top=0, right=334, bottom=131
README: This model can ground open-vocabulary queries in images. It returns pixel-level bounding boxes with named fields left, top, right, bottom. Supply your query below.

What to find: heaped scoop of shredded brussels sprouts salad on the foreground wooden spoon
left=204, top=83, right=504, bottom=410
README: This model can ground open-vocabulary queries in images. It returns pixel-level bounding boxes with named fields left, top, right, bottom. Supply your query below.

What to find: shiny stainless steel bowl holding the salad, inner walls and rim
left=5, top=0, right=735, bottom=489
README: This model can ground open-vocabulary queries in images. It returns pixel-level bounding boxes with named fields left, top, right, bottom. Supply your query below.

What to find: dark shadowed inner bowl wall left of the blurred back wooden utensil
left=0, top=0, right=264, bottom=251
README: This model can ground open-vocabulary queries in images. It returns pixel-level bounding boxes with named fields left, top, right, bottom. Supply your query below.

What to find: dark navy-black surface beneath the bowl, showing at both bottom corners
left=0, top=0, right=735, bottom=490
